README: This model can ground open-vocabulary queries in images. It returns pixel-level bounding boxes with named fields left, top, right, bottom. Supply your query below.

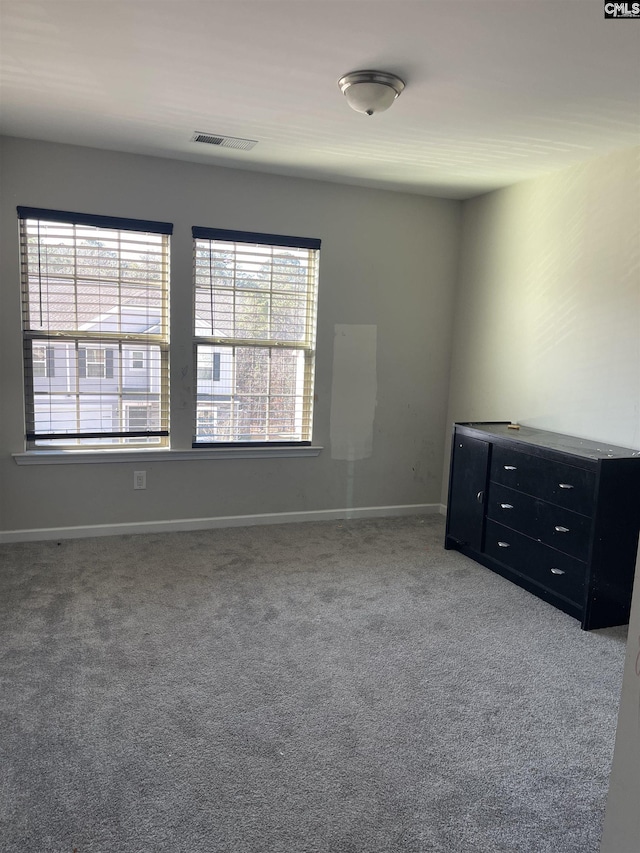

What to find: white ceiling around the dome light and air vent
left=0, top=0, right=640, bottom=198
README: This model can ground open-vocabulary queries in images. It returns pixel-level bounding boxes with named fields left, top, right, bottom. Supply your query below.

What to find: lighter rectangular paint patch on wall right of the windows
left=330, top=323, right=378, bottom=460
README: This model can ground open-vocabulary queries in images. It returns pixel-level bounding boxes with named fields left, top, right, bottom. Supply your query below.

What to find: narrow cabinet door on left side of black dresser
left=447, top=434, right=489, bottom=550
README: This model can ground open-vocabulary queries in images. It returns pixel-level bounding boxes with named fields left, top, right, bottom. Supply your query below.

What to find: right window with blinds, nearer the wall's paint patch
left=193, top=228, right=320, bottom=447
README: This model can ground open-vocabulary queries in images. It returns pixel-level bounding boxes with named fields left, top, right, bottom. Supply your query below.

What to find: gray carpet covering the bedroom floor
left=0, top=516, right=626, bottom=853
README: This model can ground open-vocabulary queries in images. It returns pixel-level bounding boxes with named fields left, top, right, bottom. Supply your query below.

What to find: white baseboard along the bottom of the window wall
left=0, top=504, right=442, bottom=543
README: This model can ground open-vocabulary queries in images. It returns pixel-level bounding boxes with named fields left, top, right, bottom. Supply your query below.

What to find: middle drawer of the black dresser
left=487, top=483, right=591, bottom=561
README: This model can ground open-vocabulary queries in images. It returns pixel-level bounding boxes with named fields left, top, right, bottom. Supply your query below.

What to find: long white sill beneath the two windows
left=12, top=445, right=323, bottom=465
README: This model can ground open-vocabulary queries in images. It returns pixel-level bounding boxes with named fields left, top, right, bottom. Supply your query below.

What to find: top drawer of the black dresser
left=491, top=446, right=596, bottom=515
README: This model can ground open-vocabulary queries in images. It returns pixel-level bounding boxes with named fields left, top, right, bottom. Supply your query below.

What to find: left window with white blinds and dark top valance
left=18, top=207, right=172, bottom=448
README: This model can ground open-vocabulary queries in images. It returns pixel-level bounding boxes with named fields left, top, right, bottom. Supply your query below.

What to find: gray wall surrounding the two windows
left=0, top=139, right=461, bottom=531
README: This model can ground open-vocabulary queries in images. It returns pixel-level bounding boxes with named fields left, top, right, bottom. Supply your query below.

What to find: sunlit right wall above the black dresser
left=447, top=149, right=640, bottom=500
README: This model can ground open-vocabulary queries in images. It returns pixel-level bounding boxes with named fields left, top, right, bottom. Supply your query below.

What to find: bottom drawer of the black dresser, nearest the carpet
left=484, top=521, right=587, bottom=607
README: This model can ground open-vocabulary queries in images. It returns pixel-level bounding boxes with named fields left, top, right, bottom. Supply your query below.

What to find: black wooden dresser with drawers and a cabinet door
left=445, top=422, right=640, bottom=630
